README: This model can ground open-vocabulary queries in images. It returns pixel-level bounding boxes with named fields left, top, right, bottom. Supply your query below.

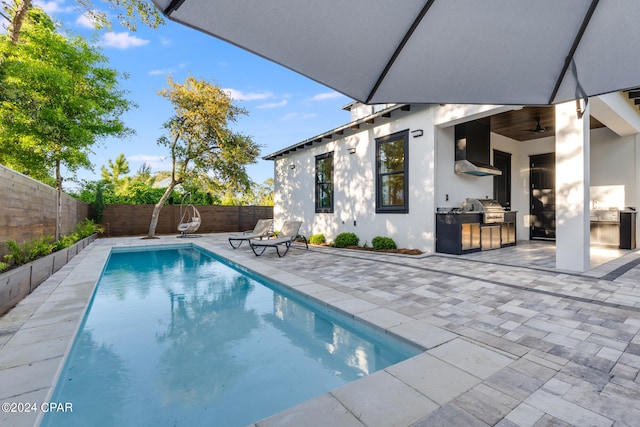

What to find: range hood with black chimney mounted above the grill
left=454, top=120, right=502, bottom=176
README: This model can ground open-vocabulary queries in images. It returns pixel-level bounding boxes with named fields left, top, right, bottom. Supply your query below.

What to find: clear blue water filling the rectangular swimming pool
left=42, top=246, right=420, bottom=427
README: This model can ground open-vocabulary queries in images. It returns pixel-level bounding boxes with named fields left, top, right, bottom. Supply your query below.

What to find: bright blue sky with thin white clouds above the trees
left=34, top=0, right=351, bottom=187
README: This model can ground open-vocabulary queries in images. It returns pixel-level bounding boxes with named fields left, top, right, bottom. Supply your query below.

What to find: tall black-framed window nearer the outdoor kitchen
left=376, top=131, right=409, bottom=213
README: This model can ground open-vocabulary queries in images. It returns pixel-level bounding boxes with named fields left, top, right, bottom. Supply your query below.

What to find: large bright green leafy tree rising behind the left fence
left=0, top=8, right=134, bottom=238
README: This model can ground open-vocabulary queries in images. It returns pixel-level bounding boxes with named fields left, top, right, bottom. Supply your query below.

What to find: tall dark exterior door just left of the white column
left=529, top=153, right=556, bottom=240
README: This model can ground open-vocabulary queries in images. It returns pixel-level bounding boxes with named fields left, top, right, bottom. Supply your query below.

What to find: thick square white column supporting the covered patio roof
left=555, top=101, right=591, bottom=272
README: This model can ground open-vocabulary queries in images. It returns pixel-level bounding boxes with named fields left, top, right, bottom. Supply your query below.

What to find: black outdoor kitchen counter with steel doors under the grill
left=436, top=211, right=517, bottom=255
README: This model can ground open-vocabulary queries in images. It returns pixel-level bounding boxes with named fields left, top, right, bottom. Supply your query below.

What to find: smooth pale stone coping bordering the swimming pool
left=0, top=235, right=536, bottom=427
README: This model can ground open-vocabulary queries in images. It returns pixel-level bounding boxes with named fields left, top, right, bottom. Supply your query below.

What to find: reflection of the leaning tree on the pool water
left=157, top=276, right=258, bottom=405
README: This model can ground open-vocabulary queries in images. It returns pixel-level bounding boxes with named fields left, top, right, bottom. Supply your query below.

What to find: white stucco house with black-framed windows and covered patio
left=265, top=91, right=640, bottom=271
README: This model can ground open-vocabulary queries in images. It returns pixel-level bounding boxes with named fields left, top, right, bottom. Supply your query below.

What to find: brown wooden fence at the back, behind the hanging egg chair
left=102, top=205, right=273, bottom=237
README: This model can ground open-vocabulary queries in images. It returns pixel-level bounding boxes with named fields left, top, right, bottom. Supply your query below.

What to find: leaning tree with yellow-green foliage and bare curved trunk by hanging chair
left=147, top=77, right=259, bottom=238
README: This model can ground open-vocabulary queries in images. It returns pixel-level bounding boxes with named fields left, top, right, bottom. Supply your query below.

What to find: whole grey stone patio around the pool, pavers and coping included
left=0, top=235, right=640, bottom=427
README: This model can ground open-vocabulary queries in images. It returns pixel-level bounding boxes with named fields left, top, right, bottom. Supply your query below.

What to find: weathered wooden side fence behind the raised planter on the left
left=0, top=165, right=89, bottom=260
